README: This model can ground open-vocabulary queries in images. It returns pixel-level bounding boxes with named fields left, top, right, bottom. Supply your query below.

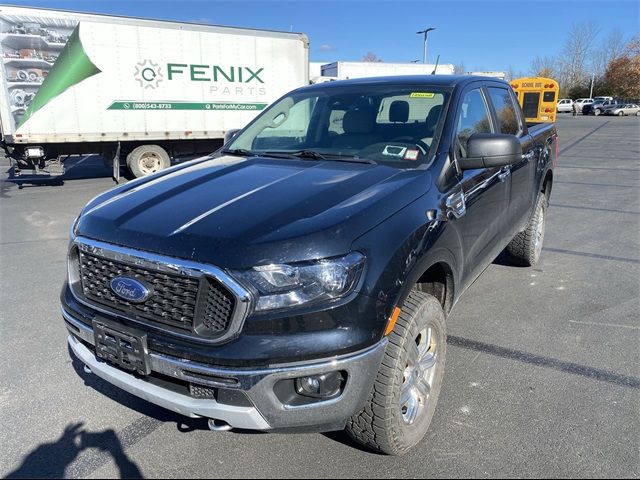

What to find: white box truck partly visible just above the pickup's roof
left=322, top=62, right=454, bottom=80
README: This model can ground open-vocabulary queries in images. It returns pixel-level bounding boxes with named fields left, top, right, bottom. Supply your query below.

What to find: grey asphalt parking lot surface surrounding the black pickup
left=0, top=115, right=640, bottom=478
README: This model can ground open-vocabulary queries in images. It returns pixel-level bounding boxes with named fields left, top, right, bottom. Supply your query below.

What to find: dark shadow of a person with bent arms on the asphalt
left=5, top=423, right=143, bottom=478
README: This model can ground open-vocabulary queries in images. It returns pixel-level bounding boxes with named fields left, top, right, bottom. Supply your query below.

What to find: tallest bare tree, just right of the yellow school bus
left=558, top=22, right=600, bottom=88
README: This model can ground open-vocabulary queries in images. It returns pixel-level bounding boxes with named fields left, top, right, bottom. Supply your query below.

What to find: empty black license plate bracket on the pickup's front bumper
left=93, top=319, right=151, bottom=376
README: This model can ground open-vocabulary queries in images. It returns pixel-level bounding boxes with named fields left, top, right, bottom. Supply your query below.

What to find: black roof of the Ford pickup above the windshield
left=301, top=75, right=509, bottom=90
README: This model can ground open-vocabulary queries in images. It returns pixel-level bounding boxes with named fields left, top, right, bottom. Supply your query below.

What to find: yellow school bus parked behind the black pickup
left=511, top=77, right=559, bottom=123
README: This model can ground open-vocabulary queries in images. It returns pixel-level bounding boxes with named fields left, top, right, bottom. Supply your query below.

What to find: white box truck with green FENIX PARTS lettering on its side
left=0, top=6, right=309, bottom=176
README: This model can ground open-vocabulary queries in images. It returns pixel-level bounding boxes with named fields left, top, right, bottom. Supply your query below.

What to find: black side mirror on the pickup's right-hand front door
left=458, top=133, right=522, bottom=170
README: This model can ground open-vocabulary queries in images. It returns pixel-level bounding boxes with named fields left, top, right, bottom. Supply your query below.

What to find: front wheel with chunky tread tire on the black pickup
left=346, top=290, right=446, bottom=455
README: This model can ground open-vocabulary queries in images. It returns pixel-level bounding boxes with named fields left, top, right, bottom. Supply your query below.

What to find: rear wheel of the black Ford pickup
left=507, top=193, right=548, bottom=267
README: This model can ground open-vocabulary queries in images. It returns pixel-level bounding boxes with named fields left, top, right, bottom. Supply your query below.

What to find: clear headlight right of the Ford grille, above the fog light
left=234, top=252, right=364, bottom=312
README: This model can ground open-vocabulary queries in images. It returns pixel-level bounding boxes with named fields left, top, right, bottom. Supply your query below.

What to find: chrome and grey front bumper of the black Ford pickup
left=62, top=308, right=387, bottom=430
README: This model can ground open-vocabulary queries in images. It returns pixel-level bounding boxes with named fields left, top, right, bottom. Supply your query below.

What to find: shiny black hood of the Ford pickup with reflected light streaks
left=76, top=156, right=431, bottom=268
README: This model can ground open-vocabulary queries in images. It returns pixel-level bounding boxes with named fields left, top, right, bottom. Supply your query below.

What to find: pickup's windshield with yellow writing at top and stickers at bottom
left=224, top=85, right=450, bottom=168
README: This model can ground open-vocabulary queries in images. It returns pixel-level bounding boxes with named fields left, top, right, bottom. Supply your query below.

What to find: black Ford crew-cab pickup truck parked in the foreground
left=61, top=76, right=558, bottom=454
